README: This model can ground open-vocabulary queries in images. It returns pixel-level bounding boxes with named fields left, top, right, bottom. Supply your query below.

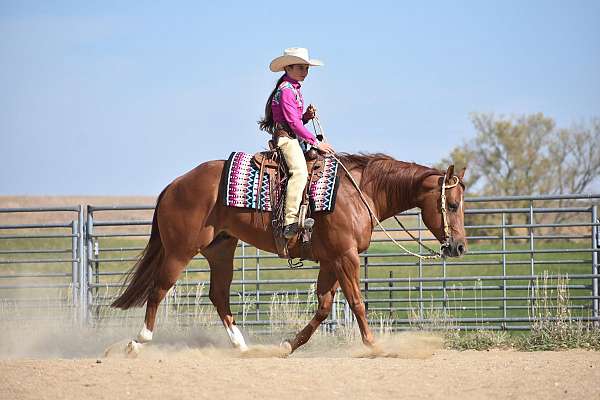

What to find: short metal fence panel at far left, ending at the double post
left=0, top=206, right=84, bottom=322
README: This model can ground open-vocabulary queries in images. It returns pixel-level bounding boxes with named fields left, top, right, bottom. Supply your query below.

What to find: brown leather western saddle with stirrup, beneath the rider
left=252, top=140, right=325, bottom=262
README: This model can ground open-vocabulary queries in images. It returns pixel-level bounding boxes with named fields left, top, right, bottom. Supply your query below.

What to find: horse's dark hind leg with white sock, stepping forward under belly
left=201, top=232, right=248, bottom=351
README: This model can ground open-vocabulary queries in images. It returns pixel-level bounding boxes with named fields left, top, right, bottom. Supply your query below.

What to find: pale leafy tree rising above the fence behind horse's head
left=440, top=113, right=600, bottom=195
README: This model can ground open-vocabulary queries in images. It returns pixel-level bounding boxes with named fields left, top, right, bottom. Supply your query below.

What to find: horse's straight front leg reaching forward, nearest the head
left=335, top=250, right=374, bottom=346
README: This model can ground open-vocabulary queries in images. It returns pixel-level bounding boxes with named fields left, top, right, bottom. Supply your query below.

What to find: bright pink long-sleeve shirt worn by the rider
left=271, top=75, right=317, bottom=145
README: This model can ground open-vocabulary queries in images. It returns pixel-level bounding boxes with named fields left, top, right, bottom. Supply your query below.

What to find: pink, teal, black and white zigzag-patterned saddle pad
left=222, top=152, right=338, bottom=211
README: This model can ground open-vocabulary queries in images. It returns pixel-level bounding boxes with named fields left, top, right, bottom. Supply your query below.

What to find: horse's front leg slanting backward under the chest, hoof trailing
left=284, top=262, right=337, bottom=352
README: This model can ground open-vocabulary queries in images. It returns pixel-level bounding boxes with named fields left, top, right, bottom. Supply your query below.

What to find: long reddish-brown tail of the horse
left=111, top=186, right=168, bottom=310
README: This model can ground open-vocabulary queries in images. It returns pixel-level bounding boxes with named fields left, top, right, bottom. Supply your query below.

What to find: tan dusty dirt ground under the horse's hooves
left=0, top=329, right=600, bottom=400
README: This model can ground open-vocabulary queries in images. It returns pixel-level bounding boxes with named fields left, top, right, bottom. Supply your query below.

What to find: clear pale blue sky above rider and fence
left=0, top=0, right=600, bottom=195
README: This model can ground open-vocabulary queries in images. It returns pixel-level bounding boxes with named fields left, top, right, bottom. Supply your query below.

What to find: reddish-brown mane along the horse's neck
left=336, top=153, right=444, bottom=209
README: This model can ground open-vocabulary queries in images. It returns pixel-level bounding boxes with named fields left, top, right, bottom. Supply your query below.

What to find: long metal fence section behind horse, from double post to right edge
left=88, top=195, right=600, bottom=330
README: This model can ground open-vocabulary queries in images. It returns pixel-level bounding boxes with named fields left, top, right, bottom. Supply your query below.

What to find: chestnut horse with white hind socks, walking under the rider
left=112, top=154, right=466, bottom=353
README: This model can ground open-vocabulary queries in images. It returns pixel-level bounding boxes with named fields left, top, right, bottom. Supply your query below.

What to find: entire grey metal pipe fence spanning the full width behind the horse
left=0, top=194, right=600, bottom=330
